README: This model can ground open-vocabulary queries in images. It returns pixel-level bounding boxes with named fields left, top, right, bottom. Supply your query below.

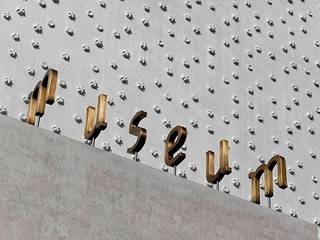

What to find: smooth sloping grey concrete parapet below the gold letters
left=0, top=116, right=317, bottom=240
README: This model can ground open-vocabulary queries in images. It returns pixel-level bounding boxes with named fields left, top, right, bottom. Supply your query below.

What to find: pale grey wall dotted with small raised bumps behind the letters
left=0, top=0, right=320, bottom=225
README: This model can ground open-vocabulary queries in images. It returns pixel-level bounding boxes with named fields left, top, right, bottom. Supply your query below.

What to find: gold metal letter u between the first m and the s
left=84, top=94, right=108, bottom=140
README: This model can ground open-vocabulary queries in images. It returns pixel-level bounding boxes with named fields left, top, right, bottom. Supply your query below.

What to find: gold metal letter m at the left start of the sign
left=26, top=68, right=58, bottom=125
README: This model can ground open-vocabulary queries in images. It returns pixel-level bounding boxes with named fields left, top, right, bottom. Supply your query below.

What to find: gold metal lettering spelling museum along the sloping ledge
left=26, top=68, right=287, bottom=204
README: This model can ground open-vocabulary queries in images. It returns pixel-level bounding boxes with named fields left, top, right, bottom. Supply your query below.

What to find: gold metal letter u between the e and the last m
left=206, top=140, right=232, bottom=184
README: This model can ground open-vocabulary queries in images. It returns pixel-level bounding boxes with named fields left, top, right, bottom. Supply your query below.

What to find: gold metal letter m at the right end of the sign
left=249, top=155, right=287, bottom=204
